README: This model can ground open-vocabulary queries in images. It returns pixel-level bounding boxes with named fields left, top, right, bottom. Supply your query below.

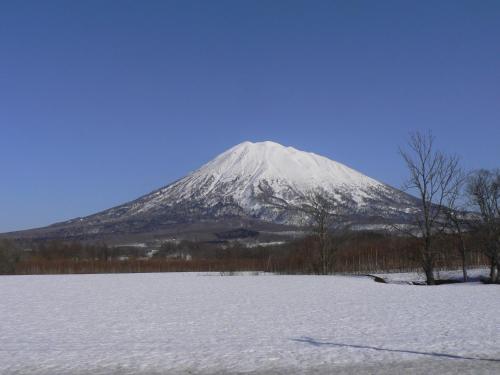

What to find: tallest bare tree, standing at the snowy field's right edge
left=400, top=132, right=459, bottom=285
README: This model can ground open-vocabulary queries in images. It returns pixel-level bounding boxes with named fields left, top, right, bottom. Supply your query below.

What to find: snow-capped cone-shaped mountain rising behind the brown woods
left=10, top=142, right=415, bottom=241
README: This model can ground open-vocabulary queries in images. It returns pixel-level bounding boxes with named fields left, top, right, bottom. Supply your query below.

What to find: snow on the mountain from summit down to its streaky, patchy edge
left=92, top=141, right=416, bottom=221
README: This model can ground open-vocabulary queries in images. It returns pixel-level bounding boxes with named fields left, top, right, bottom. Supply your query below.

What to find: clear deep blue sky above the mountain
left=0, top=0, right=500, bottom=232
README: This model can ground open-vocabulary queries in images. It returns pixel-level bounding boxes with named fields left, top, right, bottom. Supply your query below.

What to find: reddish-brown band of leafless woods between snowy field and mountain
left=0, top=231, right=488, bottom=275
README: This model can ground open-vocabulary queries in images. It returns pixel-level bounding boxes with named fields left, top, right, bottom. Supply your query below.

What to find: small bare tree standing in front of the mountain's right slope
left=259, top=185, right=353, bottom=275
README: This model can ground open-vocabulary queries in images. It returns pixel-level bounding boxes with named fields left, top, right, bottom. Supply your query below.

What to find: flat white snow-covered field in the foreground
left=0, top=273, right=500, bottom=374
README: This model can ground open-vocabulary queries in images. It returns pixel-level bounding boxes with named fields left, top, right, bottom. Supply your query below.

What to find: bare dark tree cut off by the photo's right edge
left=467, top=169, right=500, bottom=283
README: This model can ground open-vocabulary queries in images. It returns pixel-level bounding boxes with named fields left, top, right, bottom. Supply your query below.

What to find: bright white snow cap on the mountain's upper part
left=129, top=141, right=389, bottom=212
